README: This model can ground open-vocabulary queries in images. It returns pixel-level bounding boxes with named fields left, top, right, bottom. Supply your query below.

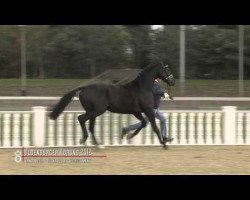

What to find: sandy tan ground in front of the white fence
left=0, top=146, right=250, bottom=175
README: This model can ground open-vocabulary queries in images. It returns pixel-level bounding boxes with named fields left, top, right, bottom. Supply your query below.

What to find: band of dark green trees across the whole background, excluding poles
left=0, top=25, right=250, bottom=79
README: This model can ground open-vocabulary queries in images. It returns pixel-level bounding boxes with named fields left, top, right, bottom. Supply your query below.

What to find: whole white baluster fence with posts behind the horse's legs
left=0, top=106, right=250, bottom=147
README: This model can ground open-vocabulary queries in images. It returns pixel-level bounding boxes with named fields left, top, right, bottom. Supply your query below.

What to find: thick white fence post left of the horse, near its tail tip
left=32, top=106, right=46, bottom=146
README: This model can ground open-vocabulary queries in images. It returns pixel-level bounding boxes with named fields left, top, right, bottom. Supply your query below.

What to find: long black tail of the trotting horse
left=49, top=87, right=84, bottom=120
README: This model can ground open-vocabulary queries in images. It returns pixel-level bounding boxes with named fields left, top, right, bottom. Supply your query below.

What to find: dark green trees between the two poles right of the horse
left=186, top=26, right=238, bottom=79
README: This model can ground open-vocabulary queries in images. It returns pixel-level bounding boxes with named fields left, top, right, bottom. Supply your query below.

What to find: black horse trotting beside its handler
left=49, top=62, right=175, bottom=148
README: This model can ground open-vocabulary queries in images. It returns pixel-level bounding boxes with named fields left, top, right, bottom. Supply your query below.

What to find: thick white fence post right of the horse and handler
left=222, top=106, right=237, bottom=145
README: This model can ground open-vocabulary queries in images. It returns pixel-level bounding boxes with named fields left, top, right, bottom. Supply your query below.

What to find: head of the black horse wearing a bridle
left=157, top=64, right=175, bottom=86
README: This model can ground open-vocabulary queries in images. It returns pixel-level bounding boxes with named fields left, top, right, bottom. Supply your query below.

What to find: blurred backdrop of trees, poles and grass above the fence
left=0, top=25, right=250, bottom=109
